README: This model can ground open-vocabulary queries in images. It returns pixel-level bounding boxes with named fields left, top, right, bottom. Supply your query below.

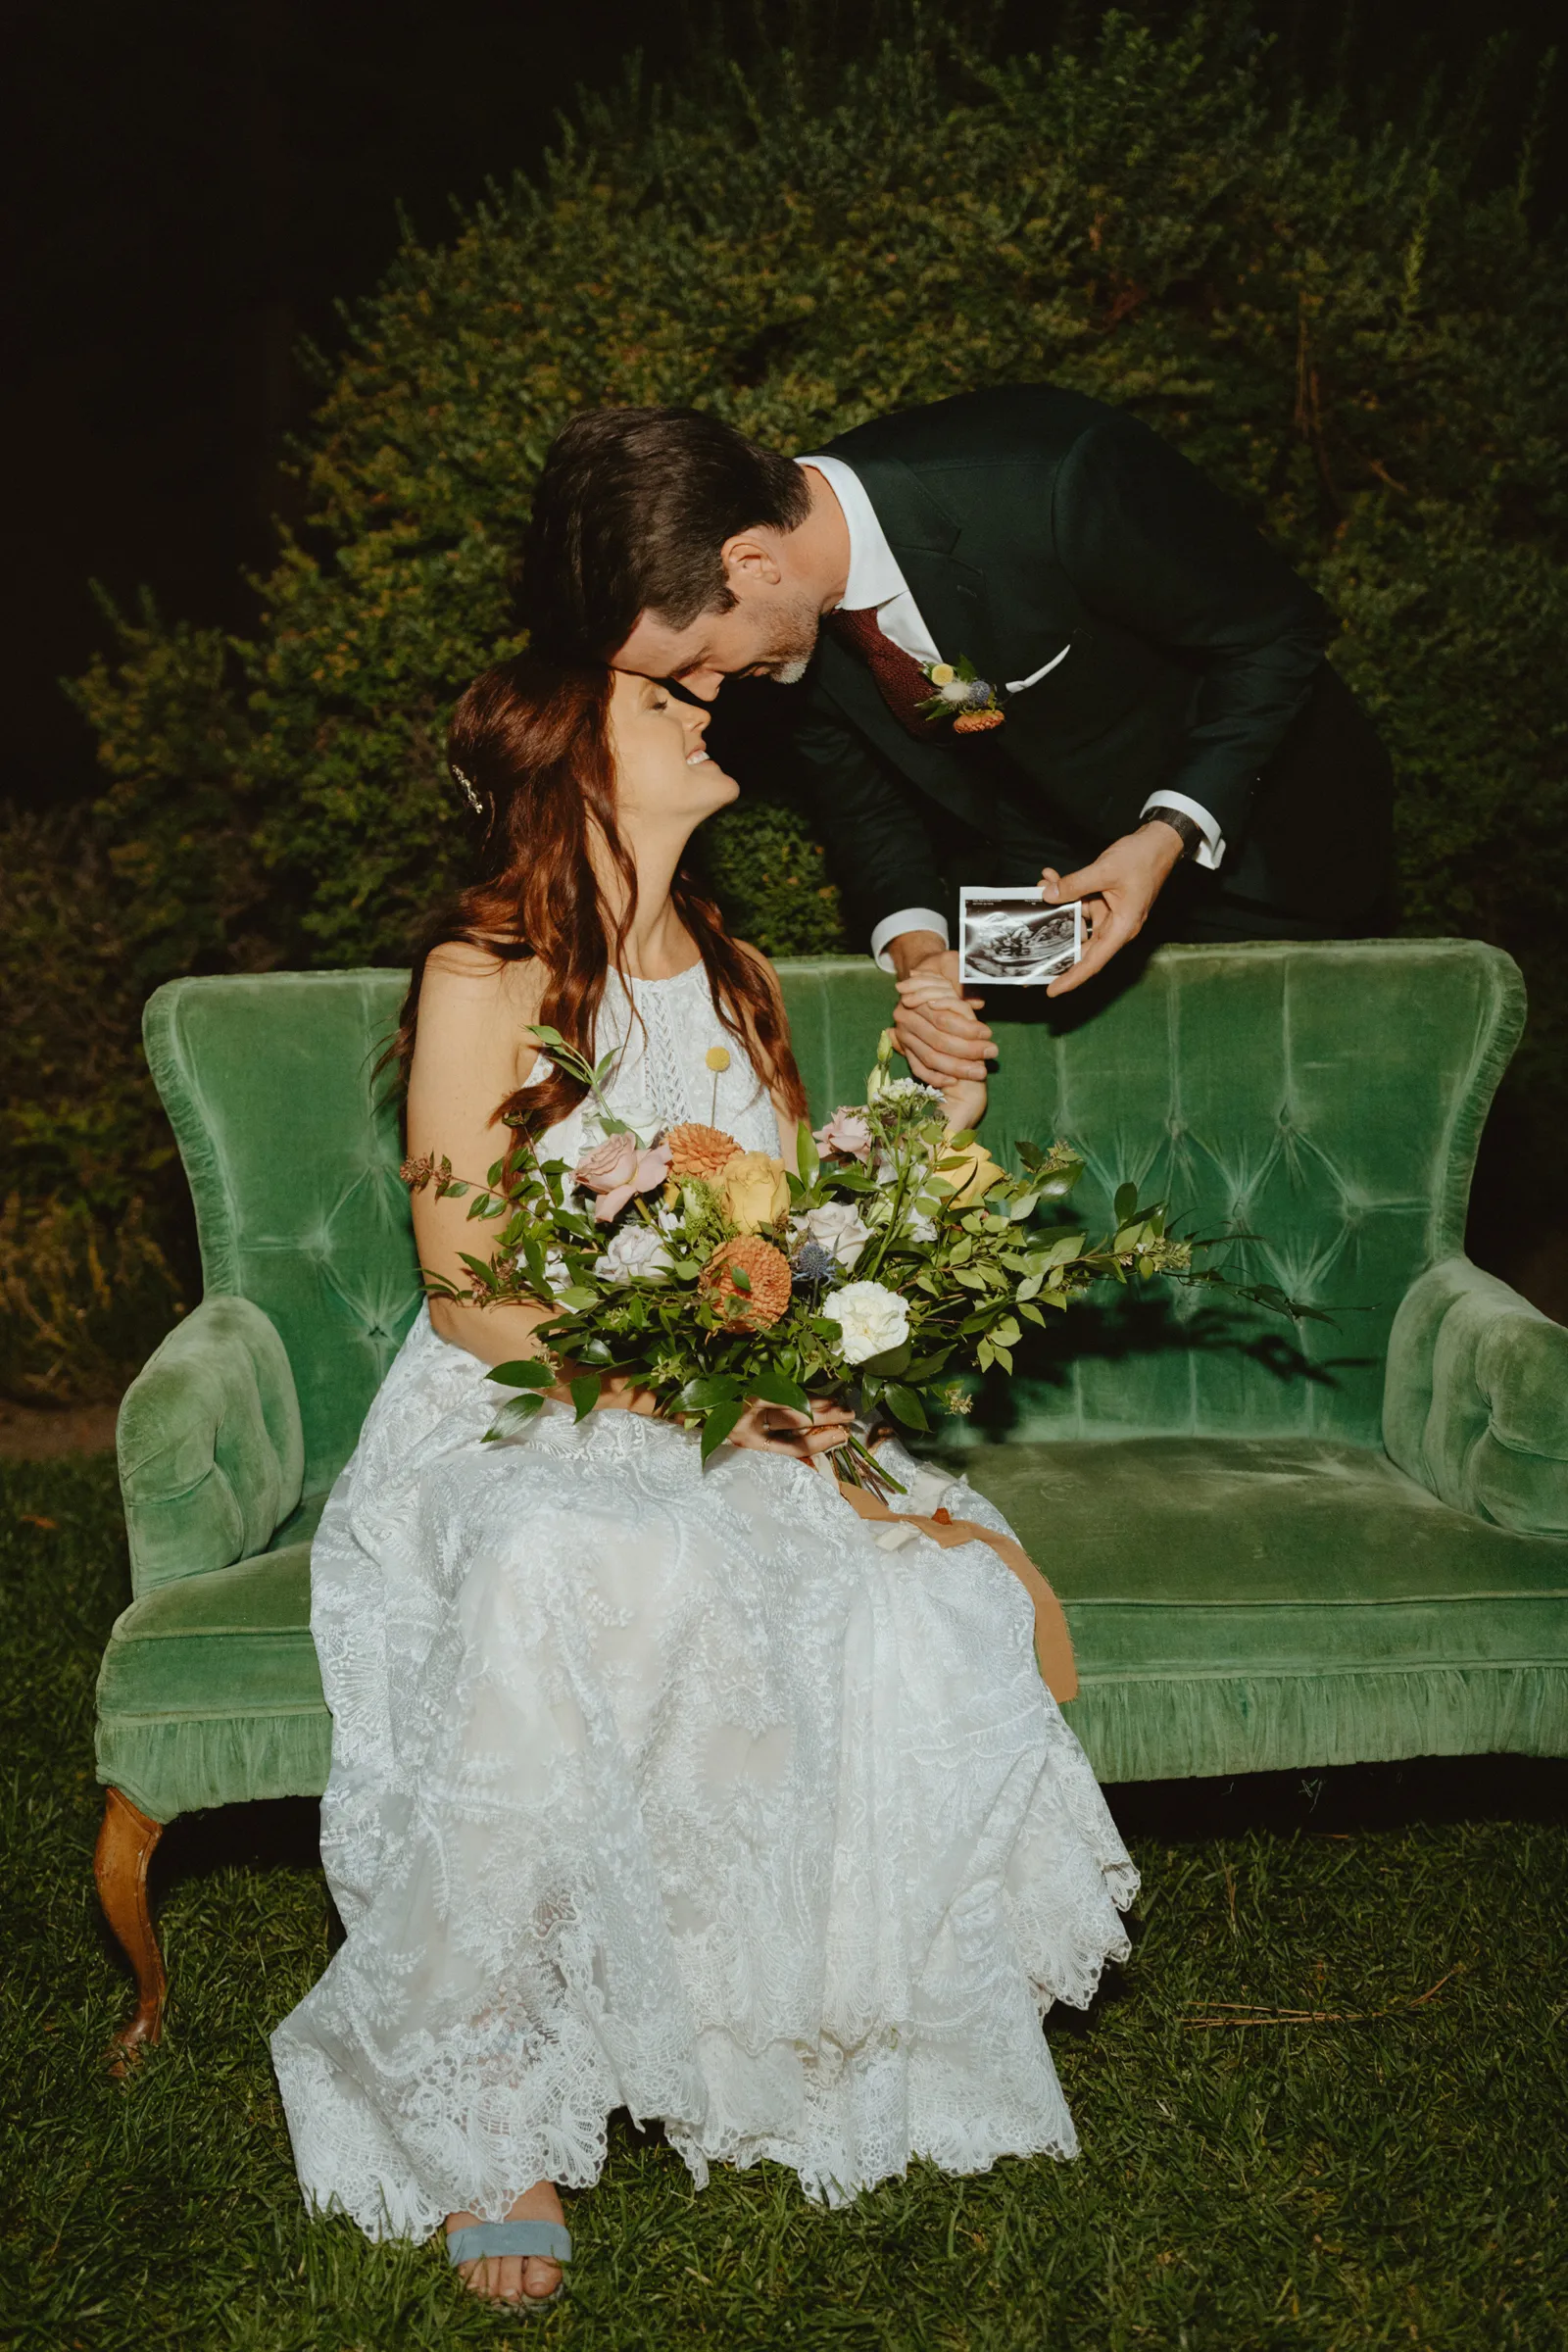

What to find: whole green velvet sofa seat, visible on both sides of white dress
left=99, top=1437, right=1568, bottom=1821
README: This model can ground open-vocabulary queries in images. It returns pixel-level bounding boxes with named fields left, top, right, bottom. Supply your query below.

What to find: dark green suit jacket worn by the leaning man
left=797, top=386, right=1390, bottom=924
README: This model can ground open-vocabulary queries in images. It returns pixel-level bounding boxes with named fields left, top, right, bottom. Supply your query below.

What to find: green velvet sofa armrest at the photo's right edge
left=1382, top=1258, right=1568, bottom=1536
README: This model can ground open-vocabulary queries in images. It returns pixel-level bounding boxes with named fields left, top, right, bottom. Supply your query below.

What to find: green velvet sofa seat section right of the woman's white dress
left=950, top=1437, right=1568, bottom=1781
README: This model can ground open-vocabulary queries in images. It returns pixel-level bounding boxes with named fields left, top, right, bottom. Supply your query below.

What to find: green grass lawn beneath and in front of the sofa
left=0, top=1460, right=1568, bottom=2352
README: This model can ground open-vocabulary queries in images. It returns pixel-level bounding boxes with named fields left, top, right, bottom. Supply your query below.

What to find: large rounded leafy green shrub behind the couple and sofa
left=33, top=12, right=1568, bottom=1373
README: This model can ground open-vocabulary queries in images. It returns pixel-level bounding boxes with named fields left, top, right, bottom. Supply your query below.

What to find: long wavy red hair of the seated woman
left=393, top=654, right=807, bottom=1136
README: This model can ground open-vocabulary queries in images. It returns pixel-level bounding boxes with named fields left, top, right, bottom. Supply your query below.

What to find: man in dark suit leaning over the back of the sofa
left=524, top=386, right=1392, bottom=1084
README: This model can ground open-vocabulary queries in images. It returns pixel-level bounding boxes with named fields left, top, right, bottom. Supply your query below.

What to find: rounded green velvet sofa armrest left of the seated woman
left=116, top=1298, right=306, bottom=1594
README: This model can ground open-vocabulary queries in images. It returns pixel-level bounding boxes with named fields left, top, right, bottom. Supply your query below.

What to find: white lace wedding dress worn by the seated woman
left=272, top=966, right=1138, bottom=2236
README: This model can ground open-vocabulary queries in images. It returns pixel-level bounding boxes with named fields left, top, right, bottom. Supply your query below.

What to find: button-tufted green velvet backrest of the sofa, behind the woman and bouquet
left=146, top=941, right=1523, bottom=1494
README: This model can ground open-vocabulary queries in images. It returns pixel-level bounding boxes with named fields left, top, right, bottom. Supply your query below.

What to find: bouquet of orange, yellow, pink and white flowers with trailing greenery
left=402, top=1028, right=1309, bottom=1487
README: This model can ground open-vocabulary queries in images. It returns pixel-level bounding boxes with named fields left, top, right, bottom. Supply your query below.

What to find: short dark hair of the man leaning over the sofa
left=522, top=410, right=811, bottom=661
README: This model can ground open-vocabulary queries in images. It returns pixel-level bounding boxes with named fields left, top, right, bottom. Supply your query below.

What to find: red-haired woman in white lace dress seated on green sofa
left=272, top=657, right=1138, bottom=2305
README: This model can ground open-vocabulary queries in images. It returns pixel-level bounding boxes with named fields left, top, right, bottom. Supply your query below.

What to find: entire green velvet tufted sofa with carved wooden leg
left=96, top=941, right=1568, bottom=2041
